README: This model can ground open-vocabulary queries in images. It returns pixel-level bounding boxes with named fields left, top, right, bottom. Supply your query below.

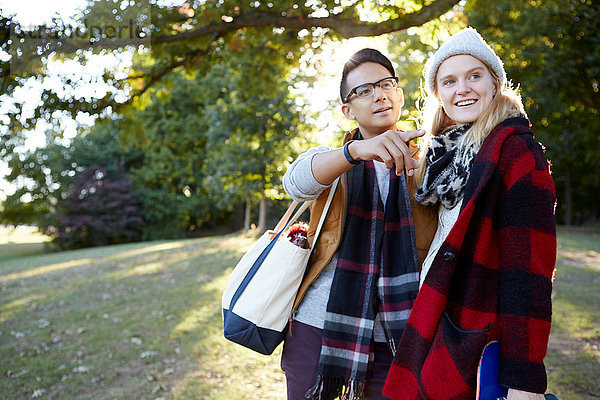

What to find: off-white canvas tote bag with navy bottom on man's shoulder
left=222, top=178, right=339, bottom=355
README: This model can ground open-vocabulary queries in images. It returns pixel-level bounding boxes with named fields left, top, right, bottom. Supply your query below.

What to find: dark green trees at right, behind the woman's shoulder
left=466, top=0, right=600, bottom=223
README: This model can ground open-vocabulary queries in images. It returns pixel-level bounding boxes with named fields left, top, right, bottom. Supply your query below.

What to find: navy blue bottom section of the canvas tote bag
left=223, top=309, right=287, bottom=356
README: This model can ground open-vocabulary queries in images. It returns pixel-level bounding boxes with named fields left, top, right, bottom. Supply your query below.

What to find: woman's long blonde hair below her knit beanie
left=415, top=64, right=526, bottom=185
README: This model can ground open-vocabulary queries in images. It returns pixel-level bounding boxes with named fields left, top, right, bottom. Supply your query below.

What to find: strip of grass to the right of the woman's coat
left=545, top=232, right=600, bottom=400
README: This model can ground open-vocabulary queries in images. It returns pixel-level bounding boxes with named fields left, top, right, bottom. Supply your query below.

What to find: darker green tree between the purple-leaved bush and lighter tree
left=121, top=74, right=219, bottom=238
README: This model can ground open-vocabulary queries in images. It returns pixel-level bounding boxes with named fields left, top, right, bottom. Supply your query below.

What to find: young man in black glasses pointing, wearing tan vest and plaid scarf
left=281, top=49, right=437, bottom=400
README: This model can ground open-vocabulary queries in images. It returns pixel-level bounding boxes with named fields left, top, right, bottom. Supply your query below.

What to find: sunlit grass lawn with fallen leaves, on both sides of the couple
left=0, top=227, right=600, bottom=400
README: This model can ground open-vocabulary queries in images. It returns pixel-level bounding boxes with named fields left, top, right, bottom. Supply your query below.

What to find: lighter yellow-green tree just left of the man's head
left=200, top=31, right=306, bottom=231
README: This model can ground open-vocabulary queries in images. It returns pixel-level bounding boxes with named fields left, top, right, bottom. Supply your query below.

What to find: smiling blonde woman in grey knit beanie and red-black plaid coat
left=384, top=28, right=556, bottom=400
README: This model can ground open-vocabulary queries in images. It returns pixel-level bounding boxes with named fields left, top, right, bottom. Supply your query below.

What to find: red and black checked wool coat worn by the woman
left=384, top=117, right=556, bottom=400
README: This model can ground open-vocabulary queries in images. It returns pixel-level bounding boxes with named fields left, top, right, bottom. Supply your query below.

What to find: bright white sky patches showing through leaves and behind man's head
left=0, top=0, right=385, bottom=201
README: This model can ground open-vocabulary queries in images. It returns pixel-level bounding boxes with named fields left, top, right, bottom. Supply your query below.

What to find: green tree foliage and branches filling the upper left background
left=0, top=0, right=464, bottom=238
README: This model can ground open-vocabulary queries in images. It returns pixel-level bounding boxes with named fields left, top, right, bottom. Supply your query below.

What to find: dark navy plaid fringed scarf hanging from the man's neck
left=306, top=157, right=419, bottom=400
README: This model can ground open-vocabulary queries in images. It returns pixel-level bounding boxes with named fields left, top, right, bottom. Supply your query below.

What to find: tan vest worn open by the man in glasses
left=293, top=129, right=437, bottom=311
